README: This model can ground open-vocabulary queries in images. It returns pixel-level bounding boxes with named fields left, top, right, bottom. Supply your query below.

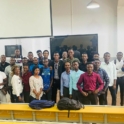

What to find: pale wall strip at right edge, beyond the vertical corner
left=117, top=0, right=124, bottom=53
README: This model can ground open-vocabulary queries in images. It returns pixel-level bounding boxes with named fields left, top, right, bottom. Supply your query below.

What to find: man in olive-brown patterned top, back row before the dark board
left=66, top=49, right=80, bottom=69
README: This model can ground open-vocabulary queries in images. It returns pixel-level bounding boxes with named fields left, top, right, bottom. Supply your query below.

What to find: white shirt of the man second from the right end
left=101, top=62, right=117, bottom=86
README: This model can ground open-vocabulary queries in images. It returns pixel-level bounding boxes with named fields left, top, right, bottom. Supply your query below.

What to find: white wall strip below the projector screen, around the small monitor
left=0, top=38, right=50, bottom=57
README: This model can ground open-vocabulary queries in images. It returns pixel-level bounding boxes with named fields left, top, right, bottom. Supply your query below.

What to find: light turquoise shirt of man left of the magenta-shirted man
left=69, top=70, right=84, bottom=94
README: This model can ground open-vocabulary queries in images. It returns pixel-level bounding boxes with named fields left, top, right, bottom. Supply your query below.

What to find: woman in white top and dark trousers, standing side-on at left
left=11, top=66, right=23, bottom=103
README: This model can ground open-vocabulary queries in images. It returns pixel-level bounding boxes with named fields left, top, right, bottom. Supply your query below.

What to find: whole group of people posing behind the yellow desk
left=0, top=49, right=124, bottom=106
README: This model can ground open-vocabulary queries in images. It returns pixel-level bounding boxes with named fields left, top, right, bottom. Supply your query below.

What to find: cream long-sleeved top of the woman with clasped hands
left=29, top=76, right=43, bottom=100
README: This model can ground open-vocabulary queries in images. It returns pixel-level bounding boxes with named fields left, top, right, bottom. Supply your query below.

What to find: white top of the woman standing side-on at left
left=11, top=75, right=23, bottom=97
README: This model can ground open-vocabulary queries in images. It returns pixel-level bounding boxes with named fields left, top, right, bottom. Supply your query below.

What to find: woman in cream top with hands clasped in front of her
left=29, top=67, right=43, bottom=101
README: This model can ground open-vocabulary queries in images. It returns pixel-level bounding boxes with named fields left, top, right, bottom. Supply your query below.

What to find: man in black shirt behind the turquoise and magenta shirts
left=79, top=53, right=88, bottom=72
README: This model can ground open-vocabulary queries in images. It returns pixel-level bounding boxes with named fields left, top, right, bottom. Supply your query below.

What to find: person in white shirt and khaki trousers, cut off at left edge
left=0, top=71, right=7, bottom=102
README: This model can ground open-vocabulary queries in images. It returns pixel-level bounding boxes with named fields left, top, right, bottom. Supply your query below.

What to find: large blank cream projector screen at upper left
left=0, top=0, right=52, bottom=39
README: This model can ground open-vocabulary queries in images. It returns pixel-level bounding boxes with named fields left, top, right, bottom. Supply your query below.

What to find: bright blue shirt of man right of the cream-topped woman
left=41, top=67, right=53, bottom=90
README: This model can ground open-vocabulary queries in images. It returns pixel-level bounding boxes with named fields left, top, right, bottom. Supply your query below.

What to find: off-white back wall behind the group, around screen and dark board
left=0, top=0, right=119, bottom=57
